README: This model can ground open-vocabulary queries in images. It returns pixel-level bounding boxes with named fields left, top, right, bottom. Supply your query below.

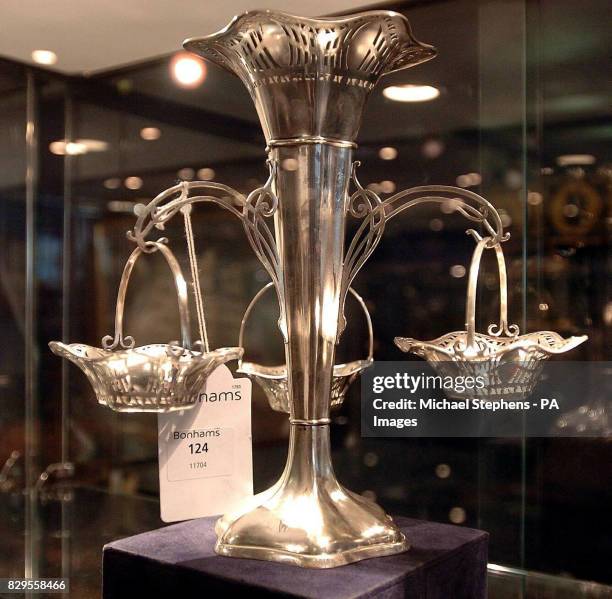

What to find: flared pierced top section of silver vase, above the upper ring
left=184, top=10, right=436, bottom=144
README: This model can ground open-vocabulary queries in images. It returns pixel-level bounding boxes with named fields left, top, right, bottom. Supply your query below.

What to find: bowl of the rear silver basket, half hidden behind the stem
left=238, top=358, right=373, bottom=414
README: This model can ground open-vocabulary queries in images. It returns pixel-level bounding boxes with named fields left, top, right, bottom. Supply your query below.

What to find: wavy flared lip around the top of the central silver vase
left=183, top=10, right=437, bottom=77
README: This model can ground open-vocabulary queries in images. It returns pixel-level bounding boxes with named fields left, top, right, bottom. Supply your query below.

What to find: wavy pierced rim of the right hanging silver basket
left=394, top=331, right=588, bottom=360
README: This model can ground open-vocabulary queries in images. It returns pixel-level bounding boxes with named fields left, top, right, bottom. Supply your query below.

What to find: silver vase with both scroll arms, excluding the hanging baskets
left=50, top=11, right=584, bottom=568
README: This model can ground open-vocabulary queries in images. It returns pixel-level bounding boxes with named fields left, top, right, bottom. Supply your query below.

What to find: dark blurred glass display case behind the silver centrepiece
left=0, top=0, right=612, bottom=599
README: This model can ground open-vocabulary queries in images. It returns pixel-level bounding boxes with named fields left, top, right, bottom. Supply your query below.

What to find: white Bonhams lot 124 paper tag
left=157, top=365, right=253, bottom=522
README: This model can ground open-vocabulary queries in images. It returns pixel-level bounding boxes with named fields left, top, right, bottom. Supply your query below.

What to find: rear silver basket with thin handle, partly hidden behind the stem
left=237, top=282, right=374, bottom=414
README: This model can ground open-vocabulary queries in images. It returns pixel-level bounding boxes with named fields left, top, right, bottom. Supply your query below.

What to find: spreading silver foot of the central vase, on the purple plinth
left=215, top=426, right=409, bottom=568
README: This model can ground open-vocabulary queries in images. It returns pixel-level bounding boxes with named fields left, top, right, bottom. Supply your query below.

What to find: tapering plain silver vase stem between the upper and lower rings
left=270, top=143, right=352, bottom=424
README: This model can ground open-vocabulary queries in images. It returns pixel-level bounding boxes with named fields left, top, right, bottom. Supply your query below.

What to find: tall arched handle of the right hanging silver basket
left=465, top=237, right=519, bottom=349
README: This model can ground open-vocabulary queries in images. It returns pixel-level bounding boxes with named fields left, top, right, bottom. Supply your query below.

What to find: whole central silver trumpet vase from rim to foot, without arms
left=185, top=11, right=435, bottom=568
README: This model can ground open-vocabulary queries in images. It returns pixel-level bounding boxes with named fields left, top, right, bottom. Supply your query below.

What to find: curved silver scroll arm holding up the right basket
left=338, top=162, right=510, bottom=340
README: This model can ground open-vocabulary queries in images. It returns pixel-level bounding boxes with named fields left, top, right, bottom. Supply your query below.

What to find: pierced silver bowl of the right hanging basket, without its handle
left=394, top=331, right=587, bottom=401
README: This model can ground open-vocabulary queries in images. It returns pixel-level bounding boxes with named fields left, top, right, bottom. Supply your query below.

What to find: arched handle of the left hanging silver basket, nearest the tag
left=102, top=240, right=191, bottom=350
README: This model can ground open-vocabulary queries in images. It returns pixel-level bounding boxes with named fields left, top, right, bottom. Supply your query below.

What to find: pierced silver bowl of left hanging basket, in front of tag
left=49, top=341, right=242, bottom=413
